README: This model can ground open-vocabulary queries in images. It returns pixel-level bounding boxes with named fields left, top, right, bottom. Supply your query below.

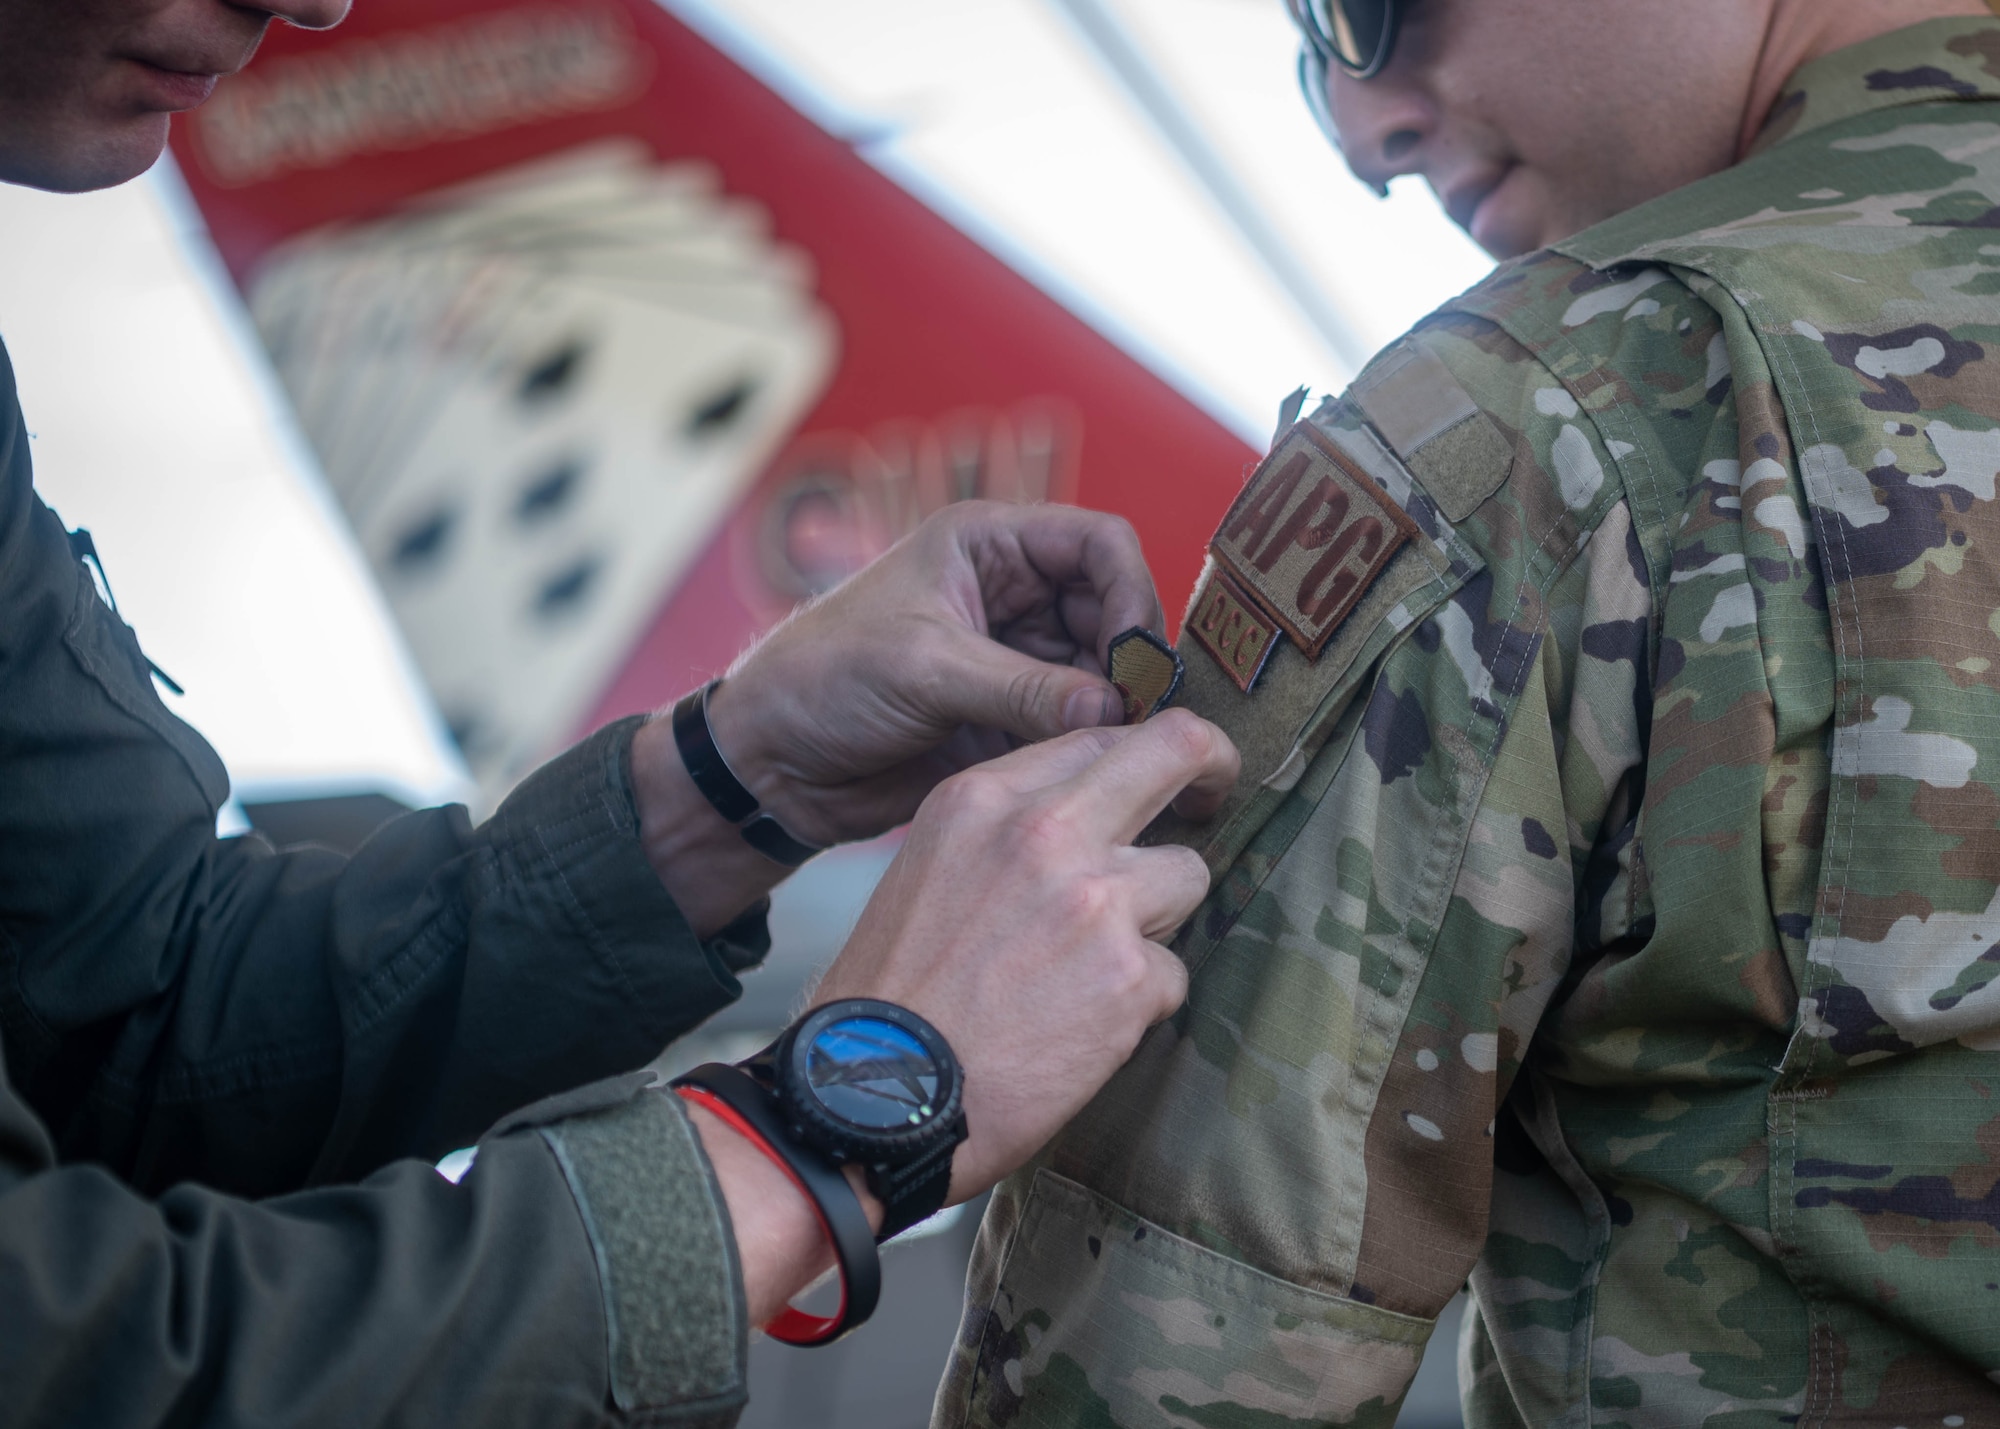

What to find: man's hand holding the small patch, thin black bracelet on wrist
left=632, top=502, right=1164, bottom=935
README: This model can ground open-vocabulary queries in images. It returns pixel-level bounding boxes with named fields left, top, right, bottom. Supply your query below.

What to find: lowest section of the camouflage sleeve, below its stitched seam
left=934, top=1167, right=1434, bottom=1429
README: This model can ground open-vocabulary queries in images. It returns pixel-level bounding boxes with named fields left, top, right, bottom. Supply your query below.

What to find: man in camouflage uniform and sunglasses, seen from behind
left=934, top=0, right=2000, bottom=1429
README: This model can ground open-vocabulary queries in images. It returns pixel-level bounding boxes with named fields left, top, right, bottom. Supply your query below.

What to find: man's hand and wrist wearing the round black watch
left=696, top=710, right=1238, bottom=1323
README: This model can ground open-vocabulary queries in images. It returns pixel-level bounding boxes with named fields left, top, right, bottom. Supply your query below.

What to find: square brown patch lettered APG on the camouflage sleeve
left=1208, top=412, right=1416, bottom=656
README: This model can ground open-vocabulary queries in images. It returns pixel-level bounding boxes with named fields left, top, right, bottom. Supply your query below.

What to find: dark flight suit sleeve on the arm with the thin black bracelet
left=0, top=330, right=764, bottom=1197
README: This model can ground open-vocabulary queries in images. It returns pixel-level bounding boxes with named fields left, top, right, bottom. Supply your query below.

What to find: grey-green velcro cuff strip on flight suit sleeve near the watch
left=492, top=1071, right=750, bottom=1429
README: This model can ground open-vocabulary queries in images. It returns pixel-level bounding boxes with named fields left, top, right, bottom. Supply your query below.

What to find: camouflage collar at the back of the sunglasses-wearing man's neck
left=1750, top=16, right=2000, bottom=154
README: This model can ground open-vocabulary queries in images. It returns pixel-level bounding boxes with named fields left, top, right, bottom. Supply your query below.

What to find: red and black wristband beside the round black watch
left=674, top=1063, right=882, bottom=1345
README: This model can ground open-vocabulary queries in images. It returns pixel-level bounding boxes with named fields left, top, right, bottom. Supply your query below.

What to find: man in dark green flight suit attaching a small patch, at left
left=0, top=0, right=1236, bottom=1429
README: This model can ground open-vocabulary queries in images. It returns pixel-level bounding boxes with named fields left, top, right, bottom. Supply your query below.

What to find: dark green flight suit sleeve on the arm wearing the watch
left=0, top=1048, right=748, bottom=1429
